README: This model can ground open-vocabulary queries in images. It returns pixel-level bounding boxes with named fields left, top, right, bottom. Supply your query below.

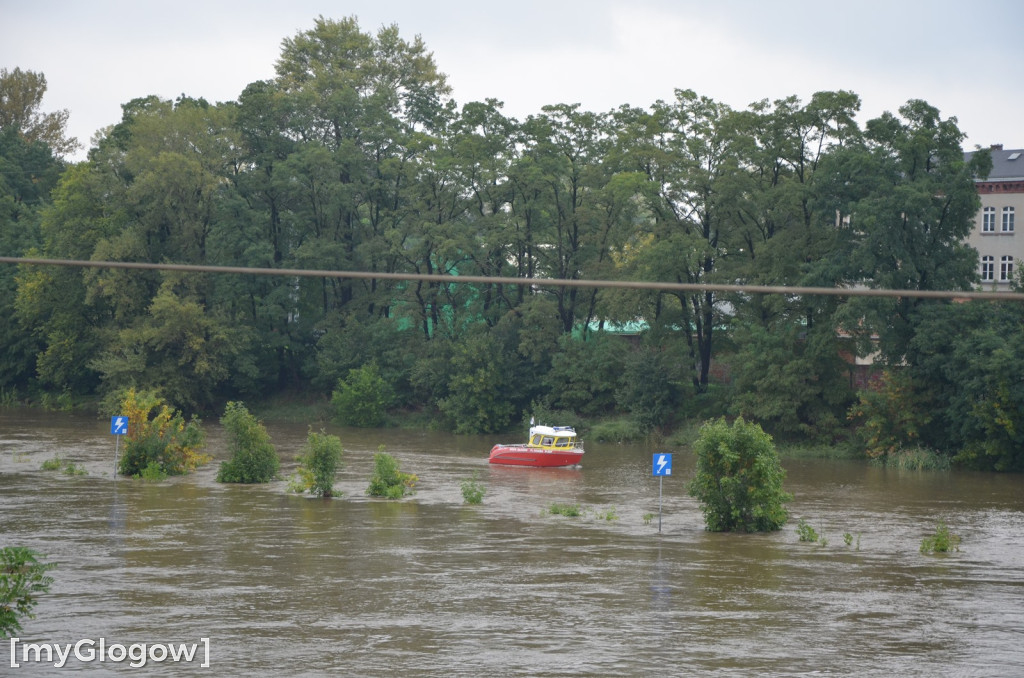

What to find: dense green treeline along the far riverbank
left=0, top=17, right=1024, bottom=469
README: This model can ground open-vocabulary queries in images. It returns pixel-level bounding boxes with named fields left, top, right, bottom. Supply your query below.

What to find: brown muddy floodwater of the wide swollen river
left=0, top=410, right=1024, bottom=678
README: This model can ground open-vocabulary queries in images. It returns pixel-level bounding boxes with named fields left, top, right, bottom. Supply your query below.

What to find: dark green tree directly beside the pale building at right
left=814, top=100, right=991, bottom=366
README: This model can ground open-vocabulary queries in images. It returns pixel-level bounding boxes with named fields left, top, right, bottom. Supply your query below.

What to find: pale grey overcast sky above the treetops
left=0, top=0, right=1024, bottom=159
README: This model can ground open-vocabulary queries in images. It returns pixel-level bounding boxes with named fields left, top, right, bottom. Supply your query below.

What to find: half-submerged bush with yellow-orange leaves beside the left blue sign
left=118, top=388, right=210, bottom=477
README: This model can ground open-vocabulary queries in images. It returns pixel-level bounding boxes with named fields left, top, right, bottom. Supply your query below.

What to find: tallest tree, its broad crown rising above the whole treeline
left=274, top=16, right=450, bottom=316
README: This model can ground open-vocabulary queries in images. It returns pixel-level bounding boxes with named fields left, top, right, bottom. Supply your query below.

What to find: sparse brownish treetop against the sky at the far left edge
left=0, top=68, right=81, bottom=158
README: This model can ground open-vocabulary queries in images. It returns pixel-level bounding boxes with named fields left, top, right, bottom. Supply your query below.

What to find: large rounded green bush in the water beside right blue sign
left=689, top=418, right=793, bottom=532
